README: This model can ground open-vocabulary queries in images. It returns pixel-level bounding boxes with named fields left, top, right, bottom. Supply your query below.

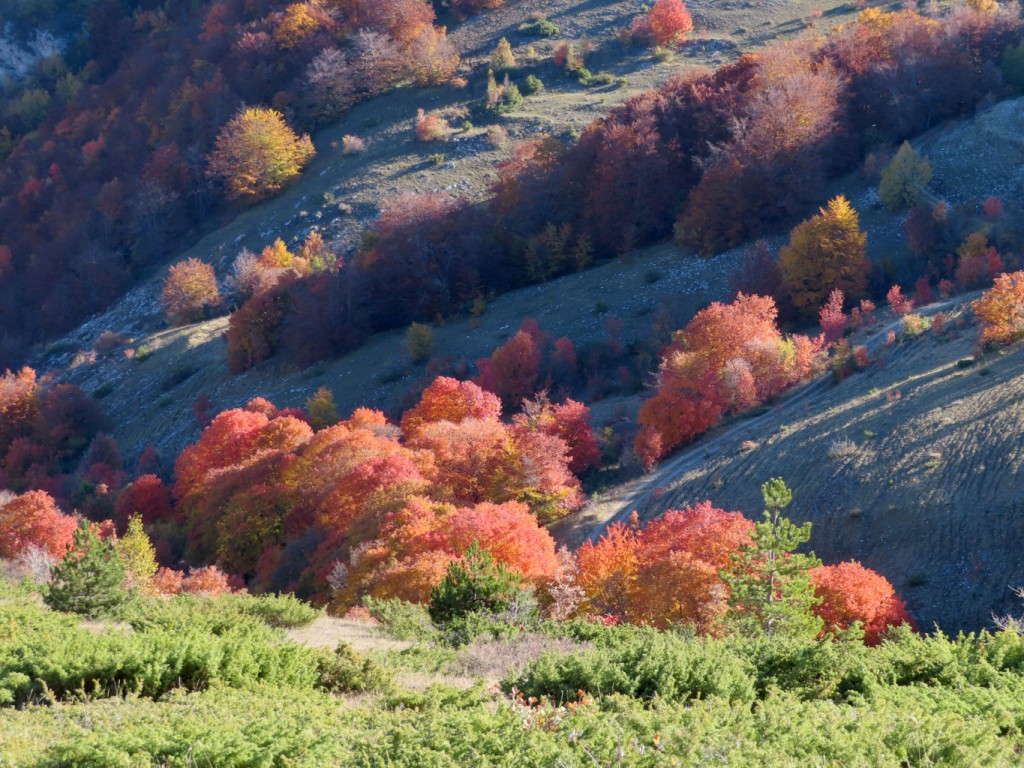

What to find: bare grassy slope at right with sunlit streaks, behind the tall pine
left=562, top=297, right=1024, bottom=632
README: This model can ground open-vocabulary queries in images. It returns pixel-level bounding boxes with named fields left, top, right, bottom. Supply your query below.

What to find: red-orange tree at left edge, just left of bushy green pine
left=0, top=490, right=78, bottom=559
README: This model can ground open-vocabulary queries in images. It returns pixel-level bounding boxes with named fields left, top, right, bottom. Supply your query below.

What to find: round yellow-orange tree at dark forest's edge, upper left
left=207, top=108, right=315, bottom=202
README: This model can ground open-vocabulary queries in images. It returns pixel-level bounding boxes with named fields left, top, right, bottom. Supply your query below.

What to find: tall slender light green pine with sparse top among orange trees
left=723, top=477, right=822, bottom=638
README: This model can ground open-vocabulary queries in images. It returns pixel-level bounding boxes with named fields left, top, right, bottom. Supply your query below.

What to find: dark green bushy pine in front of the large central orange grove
left=429, top=542, right=523, bottom=625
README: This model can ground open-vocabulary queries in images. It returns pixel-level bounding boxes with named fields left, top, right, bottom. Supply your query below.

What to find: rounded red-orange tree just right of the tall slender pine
left=810, top=561, right=913, bottom=645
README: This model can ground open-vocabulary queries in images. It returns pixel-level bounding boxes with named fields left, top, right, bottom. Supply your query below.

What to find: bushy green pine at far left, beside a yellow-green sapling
left=43, top=525, right=128, bottom=617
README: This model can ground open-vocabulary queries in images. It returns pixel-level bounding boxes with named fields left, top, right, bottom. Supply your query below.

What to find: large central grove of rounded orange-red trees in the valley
left=173, top=378, right=596, bottom=605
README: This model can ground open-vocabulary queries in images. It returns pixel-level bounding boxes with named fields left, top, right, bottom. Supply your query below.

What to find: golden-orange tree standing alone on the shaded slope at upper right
left=779, top=196, right=868, bottom=316
